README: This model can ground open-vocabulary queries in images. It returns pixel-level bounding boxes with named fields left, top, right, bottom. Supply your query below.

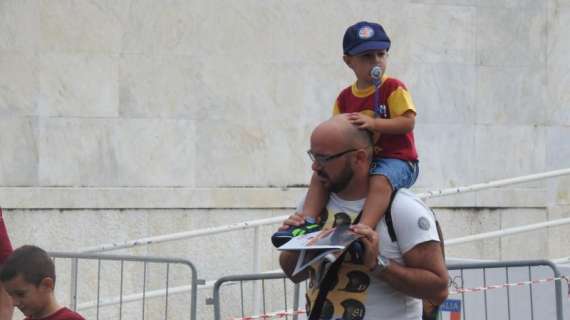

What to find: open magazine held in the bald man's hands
left=278, top=225, right=362, bottom=283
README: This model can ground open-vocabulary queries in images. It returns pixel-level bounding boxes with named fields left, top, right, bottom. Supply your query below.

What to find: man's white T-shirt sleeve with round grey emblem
left=392, top=190, right=439, bottom=254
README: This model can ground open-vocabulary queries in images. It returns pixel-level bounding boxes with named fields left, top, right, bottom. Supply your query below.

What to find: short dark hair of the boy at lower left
left=0, top=245, right=55, bottom=286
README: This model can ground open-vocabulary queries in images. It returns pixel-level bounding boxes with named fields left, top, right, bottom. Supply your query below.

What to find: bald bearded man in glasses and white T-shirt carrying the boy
left=279, top=115, right=448, bottom=320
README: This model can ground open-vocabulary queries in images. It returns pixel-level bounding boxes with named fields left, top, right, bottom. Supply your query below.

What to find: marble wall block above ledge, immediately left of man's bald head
left=195, top=120, right=310, bottom=187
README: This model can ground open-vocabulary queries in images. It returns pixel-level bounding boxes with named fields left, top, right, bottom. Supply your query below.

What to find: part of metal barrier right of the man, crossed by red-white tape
left=443, top=260, right=564, bottom=320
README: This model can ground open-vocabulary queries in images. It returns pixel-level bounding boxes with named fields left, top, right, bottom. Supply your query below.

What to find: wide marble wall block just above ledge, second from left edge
left=39, top=119, right=196, bottom=186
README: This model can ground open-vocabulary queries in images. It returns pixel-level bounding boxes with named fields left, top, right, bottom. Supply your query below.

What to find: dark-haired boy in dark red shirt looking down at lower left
left=0, top=245, right=85, bottom=320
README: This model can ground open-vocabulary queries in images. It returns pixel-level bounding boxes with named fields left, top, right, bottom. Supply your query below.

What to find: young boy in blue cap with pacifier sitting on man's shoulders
left=272, top=21, right=419, bottom=247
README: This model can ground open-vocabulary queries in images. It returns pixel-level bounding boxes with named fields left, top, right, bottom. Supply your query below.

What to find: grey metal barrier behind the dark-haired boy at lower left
left=48, top=252, right=201, bottom=320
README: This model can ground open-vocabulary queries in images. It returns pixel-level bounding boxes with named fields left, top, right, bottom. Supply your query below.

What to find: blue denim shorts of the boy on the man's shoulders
left=369, top=158, right=420, bottom=189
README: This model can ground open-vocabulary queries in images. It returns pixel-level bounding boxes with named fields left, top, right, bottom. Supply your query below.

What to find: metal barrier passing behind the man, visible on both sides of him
left=210, top=260, right=564, bottom=320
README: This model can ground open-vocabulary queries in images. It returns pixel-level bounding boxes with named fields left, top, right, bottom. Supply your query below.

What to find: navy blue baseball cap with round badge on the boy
left=342, top=21, right=390, bottom=56
